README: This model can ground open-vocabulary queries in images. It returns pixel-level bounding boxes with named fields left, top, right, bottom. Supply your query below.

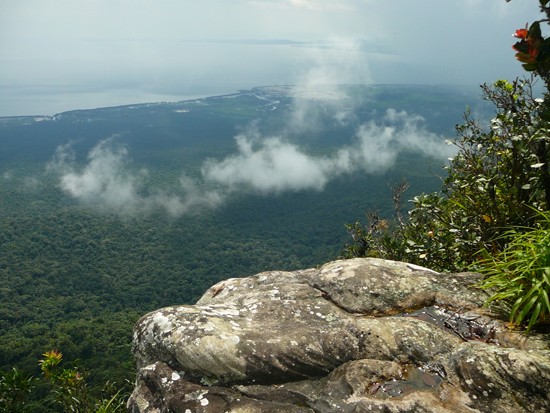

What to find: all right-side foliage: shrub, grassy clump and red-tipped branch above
left=344, top=0, right=550, bottom=332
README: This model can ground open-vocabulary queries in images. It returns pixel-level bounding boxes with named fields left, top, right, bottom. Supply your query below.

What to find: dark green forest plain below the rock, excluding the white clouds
left=0, top=85, right=491, bottom=411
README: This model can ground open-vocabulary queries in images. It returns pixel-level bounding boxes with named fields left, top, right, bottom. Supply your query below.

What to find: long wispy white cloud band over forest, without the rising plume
left=48, top=105, right=453, bottom=217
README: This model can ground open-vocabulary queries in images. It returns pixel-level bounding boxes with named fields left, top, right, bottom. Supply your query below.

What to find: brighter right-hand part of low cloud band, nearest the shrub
left=202, top=109, right=454, bottom=194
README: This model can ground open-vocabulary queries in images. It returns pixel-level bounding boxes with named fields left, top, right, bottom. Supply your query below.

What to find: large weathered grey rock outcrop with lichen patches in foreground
left=128, top=259, right=550, bottom=413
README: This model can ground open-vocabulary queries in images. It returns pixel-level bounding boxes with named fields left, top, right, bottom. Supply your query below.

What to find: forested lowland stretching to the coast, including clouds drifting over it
left=0, top=85, right=492, bottom=408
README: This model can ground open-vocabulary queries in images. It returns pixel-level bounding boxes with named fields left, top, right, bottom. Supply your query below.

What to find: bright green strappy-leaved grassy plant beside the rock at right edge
left=480, top=212, right=550, bottom=332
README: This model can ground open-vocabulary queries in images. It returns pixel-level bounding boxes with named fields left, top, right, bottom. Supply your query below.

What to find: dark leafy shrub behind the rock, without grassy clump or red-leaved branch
left=344, top=79, right=550, bottom=271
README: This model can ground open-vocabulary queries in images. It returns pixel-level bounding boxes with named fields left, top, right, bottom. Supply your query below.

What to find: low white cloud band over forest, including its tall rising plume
left=44, top=38, right=453, bottom=216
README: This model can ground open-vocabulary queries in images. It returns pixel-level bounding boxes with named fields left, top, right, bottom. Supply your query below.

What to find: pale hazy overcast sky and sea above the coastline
left=0, top=0, right=541, bottom=116
